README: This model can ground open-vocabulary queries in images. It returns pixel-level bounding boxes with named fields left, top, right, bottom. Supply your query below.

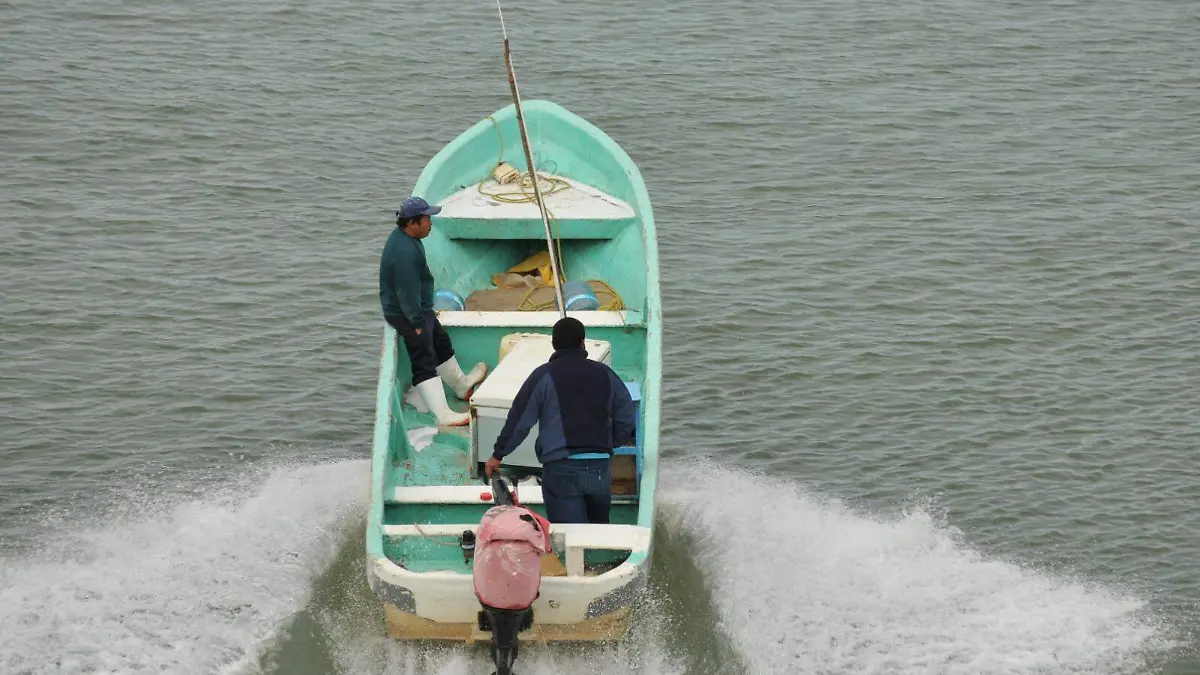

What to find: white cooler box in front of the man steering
left=470, top=333, right=612, bottom=470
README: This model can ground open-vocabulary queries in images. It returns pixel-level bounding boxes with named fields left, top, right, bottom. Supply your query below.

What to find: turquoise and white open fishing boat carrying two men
left=366, top=93, right=661, bottom=643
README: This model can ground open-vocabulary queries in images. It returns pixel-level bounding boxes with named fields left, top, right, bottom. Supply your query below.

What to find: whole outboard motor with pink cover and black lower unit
left=473, top=472, right=552, bottom=675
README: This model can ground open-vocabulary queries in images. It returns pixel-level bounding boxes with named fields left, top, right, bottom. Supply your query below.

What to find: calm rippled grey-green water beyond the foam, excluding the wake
left=0, top=0, right=1200, bottom=673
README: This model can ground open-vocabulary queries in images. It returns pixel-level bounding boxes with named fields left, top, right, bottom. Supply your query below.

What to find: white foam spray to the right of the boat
left=660, top=456, right=1170, bottom=675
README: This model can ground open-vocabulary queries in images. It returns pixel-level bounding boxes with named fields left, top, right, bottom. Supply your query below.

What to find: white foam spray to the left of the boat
left=0, top=460, right=368, bottom=675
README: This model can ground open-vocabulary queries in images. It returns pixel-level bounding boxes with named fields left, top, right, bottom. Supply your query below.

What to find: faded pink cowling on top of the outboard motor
left=473, top=506, right=551, bottom=609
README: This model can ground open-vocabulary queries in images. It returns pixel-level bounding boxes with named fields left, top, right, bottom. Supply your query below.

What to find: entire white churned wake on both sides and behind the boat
left=0, top=454, right=1172, bottom=675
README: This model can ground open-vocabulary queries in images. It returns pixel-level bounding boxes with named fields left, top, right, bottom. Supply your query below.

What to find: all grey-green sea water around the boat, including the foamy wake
left=0, top=0, right=1200, bottom=675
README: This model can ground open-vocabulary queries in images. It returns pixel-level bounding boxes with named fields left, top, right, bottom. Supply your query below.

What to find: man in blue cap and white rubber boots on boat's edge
left=379, top=197, right=487, bottom=426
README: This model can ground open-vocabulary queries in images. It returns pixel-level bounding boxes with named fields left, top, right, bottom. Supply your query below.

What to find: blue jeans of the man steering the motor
left=541, top=459, right=612, bottom=525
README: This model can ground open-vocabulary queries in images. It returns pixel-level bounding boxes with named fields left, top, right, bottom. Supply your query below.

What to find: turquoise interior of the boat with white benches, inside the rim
left=383, top=120, right=647, bottom=575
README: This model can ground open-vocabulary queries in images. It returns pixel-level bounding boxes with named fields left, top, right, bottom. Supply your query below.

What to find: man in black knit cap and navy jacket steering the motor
left=485, top=317, right=637, bottom=524
